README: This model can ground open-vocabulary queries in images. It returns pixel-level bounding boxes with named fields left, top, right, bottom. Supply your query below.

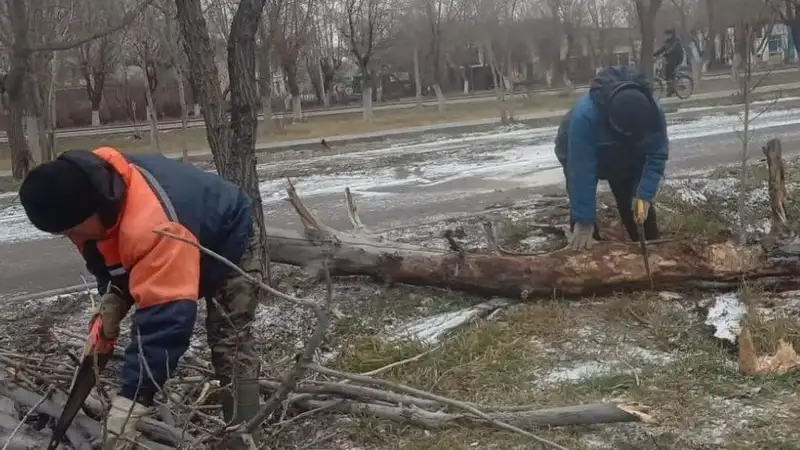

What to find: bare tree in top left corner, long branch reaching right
left=0, top=0, right=153, bottom=179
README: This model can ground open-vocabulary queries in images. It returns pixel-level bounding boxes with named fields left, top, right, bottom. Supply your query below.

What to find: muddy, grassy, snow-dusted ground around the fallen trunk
left=0, top=156, right=800, bottom=450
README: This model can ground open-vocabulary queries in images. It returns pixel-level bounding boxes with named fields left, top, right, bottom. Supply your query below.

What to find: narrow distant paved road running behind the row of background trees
left=0, top=68, right=800, bottom=142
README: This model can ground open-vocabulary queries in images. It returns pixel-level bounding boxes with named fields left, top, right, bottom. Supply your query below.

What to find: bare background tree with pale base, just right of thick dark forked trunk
left=268, top=0, right=316, bottom=122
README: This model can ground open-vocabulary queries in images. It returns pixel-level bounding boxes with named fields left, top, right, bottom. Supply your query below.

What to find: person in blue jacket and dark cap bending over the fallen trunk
left=555, top=66, right=669, bottom=250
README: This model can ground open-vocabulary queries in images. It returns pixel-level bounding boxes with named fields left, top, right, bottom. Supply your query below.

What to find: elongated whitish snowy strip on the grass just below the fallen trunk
left=387, top=298, right=512, bottom=345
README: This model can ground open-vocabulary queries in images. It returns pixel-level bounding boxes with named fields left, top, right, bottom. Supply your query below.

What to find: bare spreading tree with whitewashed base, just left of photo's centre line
left=341, top=0, right=392, bottom=122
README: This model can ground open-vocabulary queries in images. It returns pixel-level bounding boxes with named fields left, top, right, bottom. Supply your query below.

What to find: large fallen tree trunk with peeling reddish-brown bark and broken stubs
left=267, top=184, right=800, bottom=299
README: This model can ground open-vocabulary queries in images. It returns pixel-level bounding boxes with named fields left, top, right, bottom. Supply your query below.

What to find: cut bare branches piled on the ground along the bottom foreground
left=0, top=330, right=651, bottom=450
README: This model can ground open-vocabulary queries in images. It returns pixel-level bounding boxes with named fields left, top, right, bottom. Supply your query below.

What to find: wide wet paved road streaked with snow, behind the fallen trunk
left=0, top=103, right=800, bottom=298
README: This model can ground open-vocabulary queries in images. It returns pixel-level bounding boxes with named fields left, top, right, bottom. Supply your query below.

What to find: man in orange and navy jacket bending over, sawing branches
left=19, top=147, right=264, bottom=446
